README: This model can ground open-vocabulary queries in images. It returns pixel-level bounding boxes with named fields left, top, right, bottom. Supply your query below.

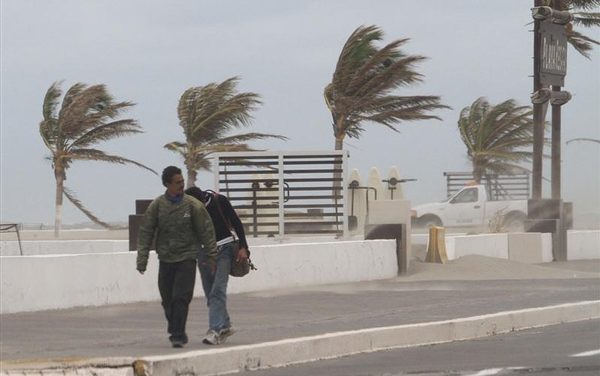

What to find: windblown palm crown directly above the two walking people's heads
left=164, top=77, right=287, bottom=187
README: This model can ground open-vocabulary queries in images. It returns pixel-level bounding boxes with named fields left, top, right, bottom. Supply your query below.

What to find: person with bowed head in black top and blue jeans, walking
left=185, top=187, right=249, bottom=345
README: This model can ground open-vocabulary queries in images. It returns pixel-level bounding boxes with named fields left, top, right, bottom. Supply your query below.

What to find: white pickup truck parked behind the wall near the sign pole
left=411, top=185, right=527, bottom=231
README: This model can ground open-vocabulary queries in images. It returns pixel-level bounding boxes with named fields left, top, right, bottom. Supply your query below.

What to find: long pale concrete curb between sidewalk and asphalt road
left=0, top=300, right=600, bottom=376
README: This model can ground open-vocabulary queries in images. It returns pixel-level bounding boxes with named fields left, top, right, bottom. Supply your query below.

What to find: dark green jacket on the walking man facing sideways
left=137, top=194, right=217, bottom=271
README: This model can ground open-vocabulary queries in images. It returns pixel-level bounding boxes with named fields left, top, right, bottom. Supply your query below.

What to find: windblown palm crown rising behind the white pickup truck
left=458, top=97, right=533, bottom=183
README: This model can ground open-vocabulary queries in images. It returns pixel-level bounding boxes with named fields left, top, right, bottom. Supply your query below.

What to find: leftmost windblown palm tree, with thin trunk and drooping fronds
left=40, top=82, right=156, bottom=237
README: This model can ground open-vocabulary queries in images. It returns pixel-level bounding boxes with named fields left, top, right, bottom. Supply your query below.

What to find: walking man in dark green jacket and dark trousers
left=137, top=166, right=217, bottom=347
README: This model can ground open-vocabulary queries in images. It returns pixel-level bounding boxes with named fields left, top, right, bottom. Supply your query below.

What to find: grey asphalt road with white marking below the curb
left=242, top=320, right=600, bottom=376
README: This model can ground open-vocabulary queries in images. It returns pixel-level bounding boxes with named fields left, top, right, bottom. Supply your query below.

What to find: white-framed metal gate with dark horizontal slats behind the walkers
left=214, top=151, right=348, bottom=237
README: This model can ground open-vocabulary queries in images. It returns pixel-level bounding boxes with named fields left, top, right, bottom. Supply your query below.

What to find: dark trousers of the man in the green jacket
left=158, top=260, right=196, bottom=339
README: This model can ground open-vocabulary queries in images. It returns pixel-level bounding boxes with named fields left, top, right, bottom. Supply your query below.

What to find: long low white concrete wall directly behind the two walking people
left=0, top=240, right=398, bottom=314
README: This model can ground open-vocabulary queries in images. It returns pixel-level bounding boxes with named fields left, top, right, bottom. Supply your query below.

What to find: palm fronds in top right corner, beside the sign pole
left=554, top=0, right=600, bottom=59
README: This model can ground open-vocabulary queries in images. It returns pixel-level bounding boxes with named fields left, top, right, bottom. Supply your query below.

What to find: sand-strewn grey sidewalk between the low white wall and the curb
left=0, top=256, right=600, bottom=370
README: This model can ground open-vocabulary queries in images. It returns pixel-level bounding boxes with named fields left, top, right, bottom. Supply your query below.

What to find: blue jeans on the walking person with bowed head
left=198, top=242, right=235, bottom=333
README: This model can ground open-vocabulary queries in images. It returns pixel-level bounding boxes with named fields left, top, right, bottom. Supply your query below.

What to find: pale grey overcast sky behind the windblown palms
left=0, top=0, right=600, bottom=223
